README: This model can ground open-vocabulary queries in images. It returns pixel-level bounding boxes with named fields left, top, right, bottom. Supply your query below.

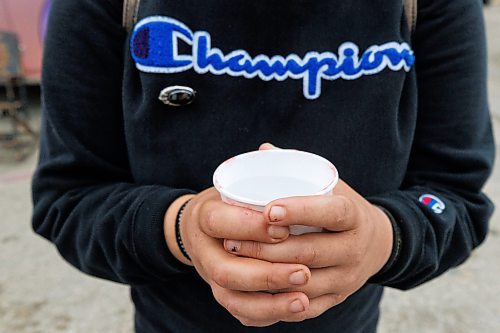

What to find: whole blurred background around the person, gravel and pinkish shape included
left=0, top=0, right=500, bottom=333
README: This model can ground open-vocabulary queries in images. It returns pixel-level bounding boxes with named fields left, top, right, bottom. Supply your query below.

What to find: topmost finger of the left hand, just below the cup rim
left=200, top=200, right=290, bottom=243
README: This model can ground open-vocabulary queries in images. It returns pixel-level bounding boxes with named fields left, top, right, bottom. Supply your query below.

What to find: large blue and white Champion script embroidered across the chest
left=130, top=16, right=415, bottom=99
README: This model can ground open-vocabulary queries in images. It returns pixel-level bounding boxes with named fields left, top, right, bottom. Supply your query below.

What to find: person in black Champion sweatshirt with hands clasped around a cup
left=33, top=0, right=494, bottom=333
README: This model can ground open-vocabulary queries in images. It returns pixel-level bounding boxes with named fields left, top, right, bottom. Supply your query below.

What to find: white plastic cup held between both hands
left=213, top=149, right=339, bottom=235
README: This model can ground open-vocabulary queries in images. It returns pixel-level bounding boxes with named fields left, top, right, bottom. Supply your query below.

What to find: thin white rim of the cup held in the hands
left=213, top=149, right=339, bottom=207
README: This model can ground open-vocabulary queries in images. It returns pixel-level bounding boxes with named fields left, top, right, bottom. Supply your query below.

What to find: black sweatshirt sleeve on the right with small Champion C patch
left=368, top=0, right=495, bottom=289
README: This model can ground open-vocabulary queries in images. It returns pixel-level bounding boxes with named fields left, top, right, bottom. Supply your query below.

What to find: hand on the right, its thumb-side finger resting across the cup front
left=224, top=146, right=392, bottom=318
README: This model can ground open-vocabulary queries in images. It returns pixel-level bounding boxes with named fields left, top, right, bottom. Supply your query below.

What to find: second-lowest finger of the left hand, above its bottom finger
left=208, top=251, right=311, bottom=291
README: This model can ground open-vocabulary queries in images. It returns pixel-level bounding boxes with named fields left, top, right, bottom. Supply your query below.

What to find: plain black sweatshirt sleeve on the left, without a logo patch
left=32, top=0, right=190, bottom=284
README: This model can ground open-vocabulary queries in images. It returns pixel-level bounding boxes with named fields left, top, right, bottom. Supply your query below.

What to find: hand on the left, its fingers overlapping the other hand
left=170, top=188, right=311, bottom=326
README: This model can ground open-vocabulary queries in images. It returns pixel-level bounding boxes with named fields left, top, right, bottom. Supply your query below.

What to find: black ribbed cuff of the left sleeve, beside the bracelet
left=132, top=186, right=194, bottom=280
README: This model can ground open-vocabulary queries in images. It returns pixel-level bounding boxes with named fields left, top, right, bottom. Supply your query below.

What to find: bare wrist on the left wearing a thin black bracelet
left=163, top=194, right=194, bottom=266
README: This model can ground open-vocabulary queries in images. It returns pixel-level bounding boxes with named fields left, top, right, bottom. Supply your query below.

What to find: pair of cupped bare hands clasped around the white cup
left=169, top=144, right=393, bottom=326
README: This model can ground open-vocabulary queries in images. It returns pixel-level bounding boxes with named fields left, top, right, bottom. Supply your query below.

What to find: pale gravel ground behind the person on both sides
left=0, top=0, right=500, bottom=333
